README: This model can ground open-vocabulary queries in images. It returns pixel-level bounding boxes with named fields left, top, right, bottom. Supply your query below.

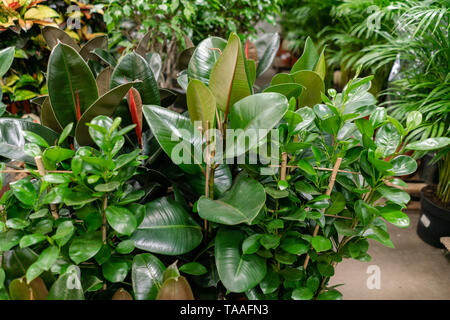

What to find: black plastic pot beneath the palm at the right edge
left=417, top=186, right=450, bottom=248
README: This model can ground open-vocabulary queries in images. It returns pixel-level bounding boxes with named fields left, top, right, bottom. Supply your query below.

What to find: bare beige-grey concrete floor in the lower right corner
left=330, top=211, right=450, bottom=300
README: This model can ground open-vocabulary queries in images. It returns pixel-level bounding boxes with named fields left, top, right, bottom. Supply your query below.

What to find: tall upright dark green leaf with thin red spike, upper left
left=47, top=43, right=98, bottom=127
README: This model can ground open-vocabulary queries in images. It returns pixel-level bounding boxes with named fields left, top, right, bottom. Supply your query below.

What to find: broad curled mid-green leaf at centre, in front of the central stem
left=197, top=178, right=266, bottom=225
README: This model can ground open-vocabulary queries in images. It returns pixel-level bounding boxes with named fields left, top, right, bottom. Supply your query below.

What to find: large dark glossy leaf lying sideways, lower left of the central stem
left=131, top=197, right=202, bottom=255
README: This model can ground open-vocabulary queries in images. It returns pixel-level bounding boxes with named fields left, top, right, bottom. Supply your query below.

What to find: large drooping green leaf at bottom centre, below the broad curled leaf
left=214, top=229, right=267, bottom=292
